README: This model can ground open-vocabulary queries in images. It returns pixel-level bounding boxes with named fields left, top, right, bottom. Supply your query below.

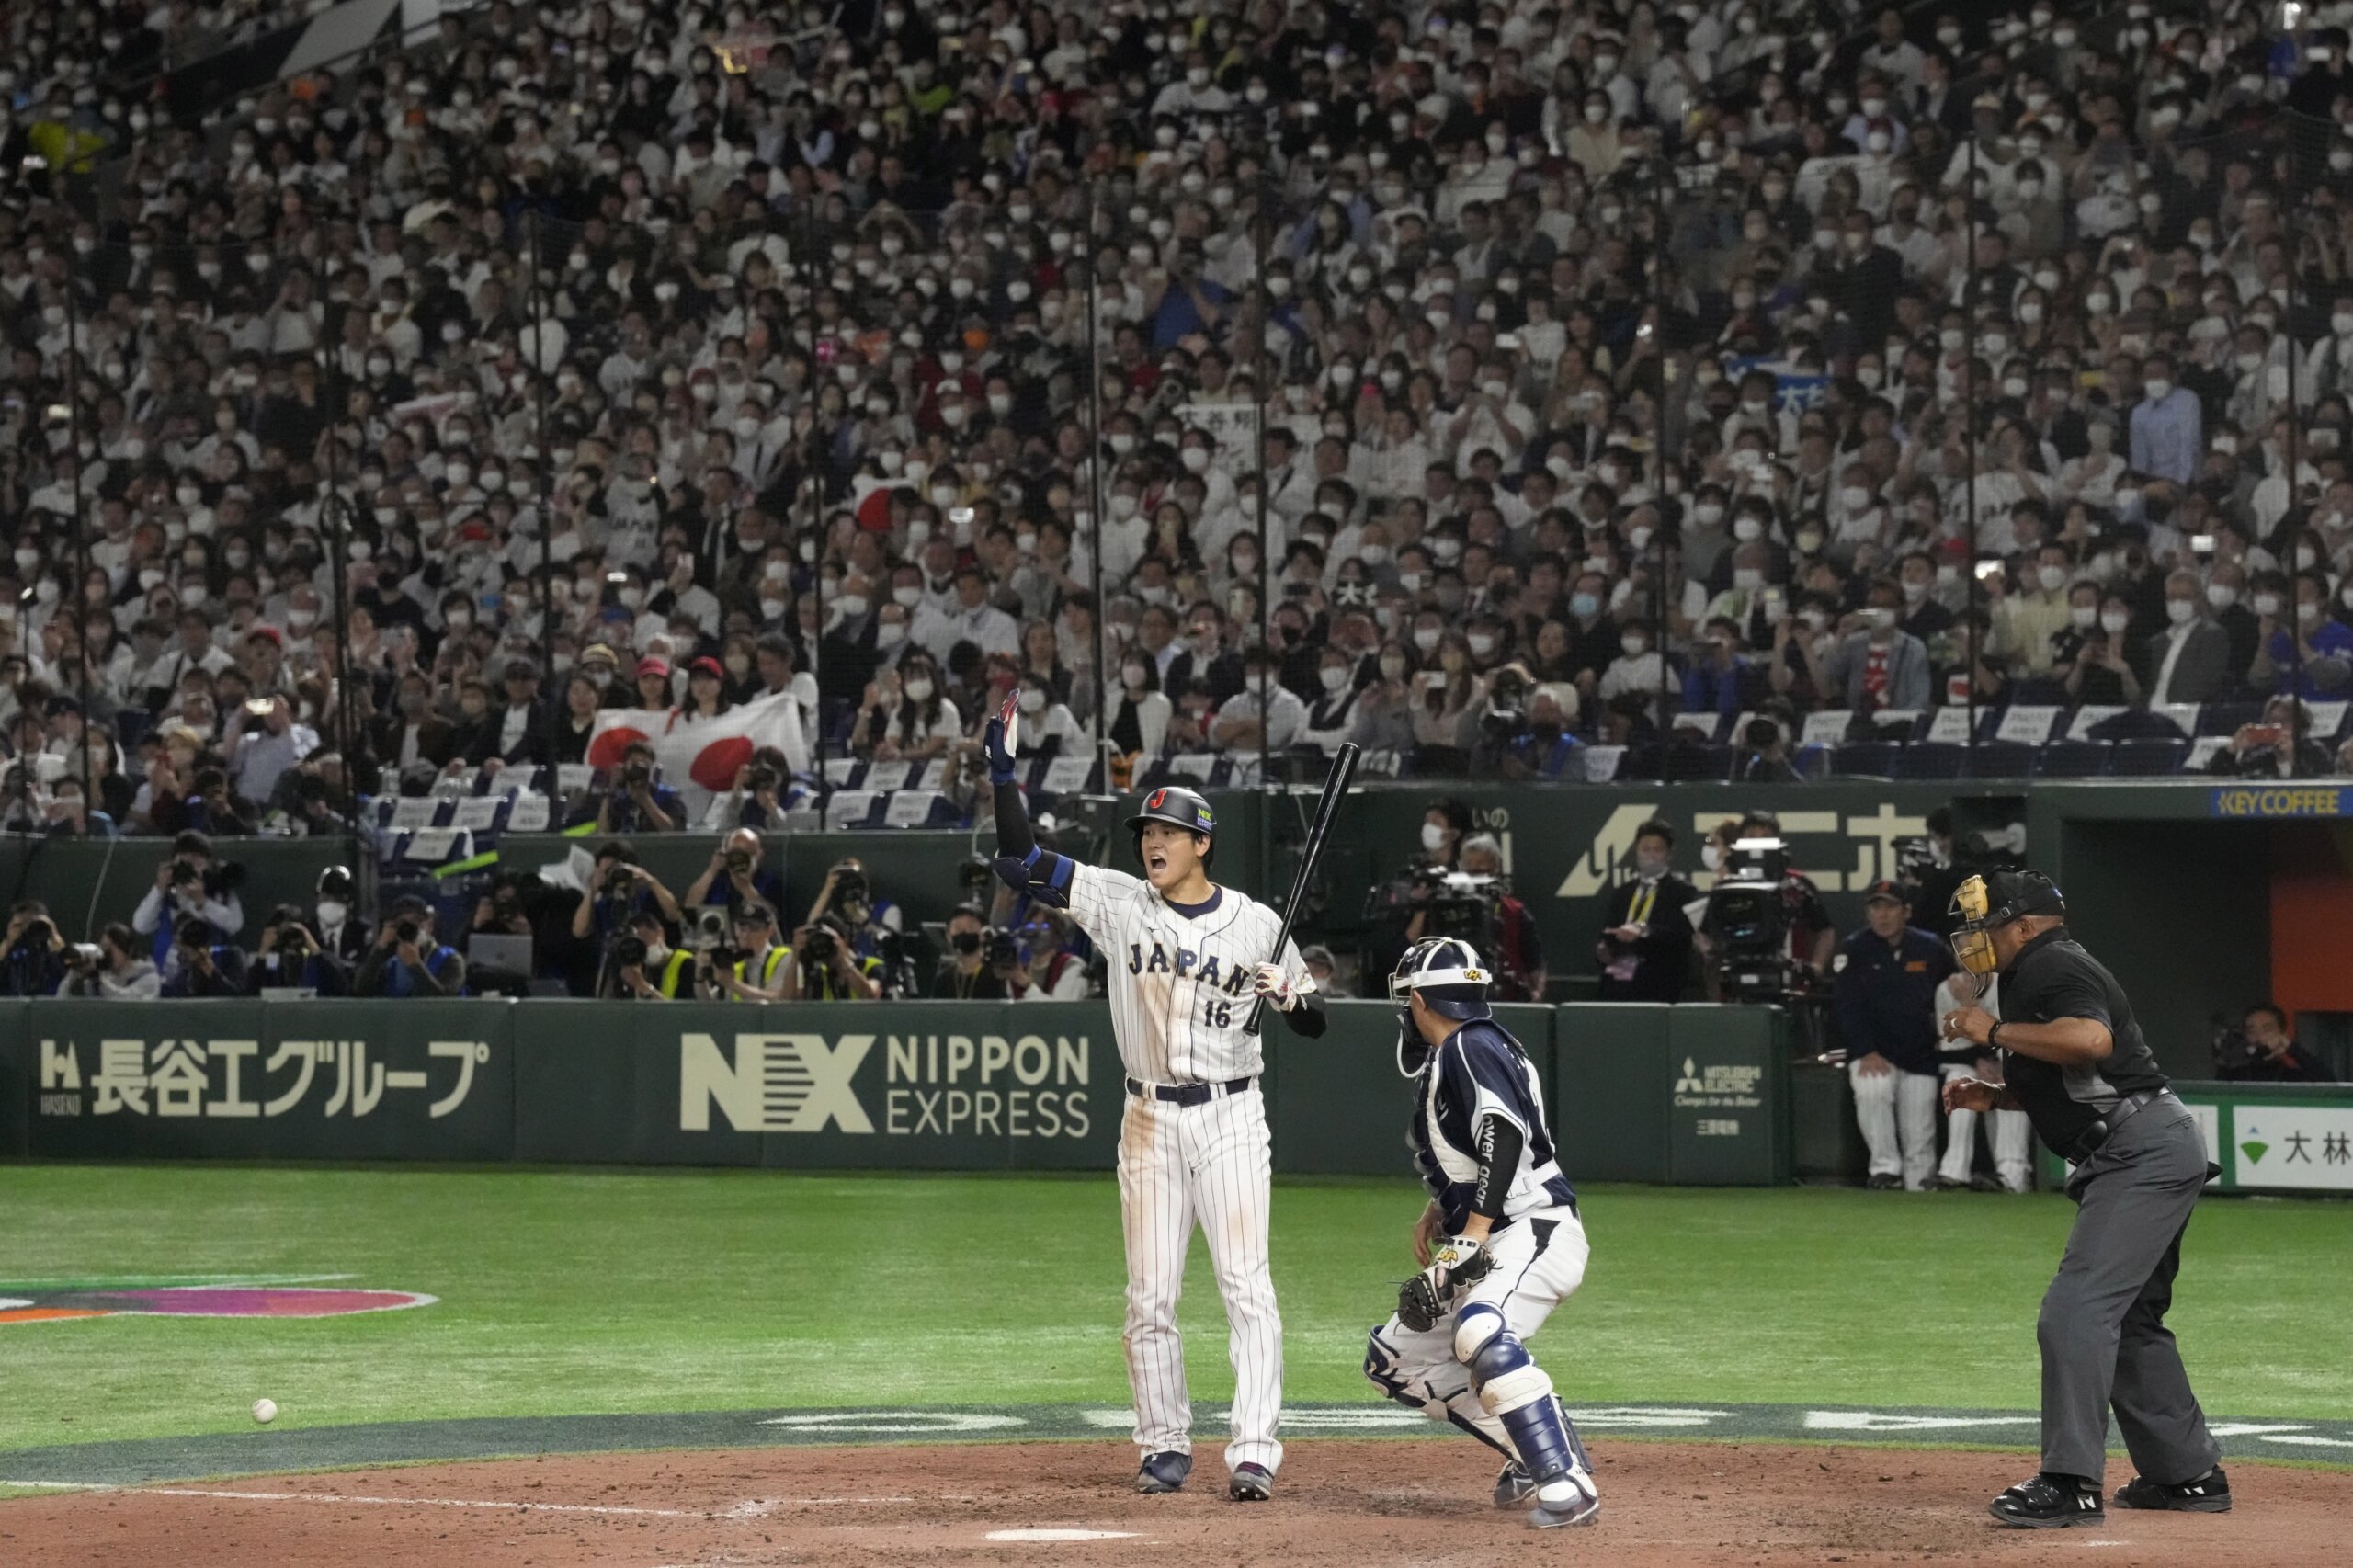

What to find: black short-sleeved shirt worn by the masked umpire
left=2003, top=926, right=2167, bottom=1158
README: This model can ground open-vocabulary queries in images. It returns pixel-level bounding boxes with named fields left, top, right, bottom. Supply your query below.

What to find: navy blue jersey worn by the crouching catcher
left=1404, top=1019, right=1576, bottom=1236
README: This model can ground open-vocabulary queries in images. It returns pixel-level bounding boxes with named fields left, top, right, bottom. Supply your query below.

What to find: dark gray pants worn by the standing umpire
left=2035, top=1099, right=2222, bottom=1485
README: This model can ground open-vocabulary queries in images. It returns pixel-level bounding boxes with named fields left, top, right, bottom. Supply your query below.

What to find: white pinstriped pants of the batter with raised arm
left=1120, top=1085, right=1282, bottom=1471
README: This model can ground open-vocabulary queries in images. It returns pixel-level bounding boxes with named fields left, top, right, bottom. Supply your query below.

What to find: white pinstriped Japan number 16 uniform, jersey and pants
left=1068, top=867, right=1306, bottom=1471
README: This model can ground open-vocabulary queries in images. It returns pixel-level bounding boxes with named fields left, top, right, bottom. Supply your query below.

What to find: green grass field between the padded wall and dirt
left=0, top=1165, right=2353, bottom=1450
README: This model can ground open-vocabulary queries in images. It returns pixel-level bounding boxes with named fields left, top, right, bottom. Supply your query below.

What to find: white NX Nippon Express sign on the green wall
left=677, top=1031, right=1099, bottom=1140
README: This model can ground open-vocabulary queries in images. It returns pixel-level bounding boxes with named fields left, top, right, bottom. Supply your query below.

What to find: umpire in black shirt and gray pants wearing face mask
left=1941, top=871, right=2231, bottom=1528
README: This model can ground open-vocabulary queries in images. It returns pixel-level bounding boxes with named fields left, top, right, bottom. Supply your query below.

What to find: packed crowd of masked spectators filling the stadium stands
left=0, top=0, right=2353, bottom=840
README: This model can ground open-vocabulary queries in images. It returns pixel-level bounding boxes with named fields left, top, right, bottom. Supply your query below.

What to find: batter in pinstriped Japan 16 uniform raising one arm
left=983, top=701, right=1324, bottom=1502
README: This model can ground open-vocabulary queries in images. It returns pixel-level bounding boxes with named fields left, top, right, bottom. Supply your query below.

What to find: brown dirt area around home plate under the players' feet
left=0, top=1438, right=2353, bottom=1568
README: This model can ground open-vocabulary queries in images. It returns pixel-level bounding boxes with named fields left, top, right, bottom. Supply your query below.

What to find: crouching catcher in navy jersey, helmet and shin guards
left=1365, top=937, right=1602, bottom=1530
